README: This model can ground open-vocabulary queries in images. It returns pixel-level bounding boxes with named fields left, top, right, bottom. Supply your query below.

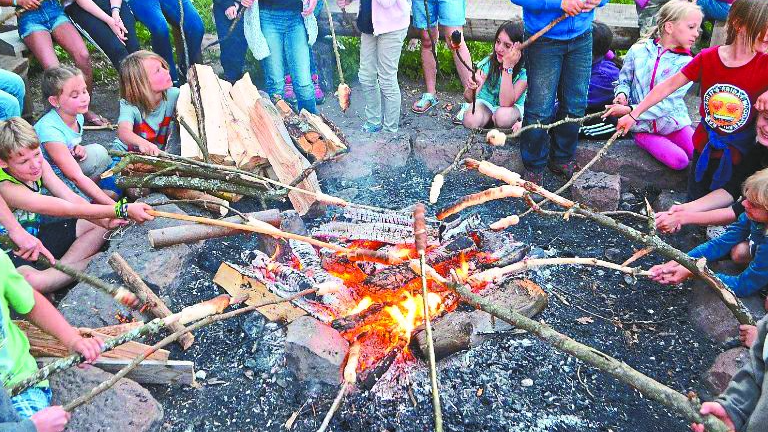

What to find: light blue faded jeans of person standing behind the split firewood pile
left=259, top=9, right=317, bottom=113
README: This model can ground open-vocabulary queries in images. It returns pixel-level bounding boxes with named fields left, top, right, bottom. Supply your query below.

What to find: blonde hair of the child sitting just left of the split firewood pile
left=120, top=50, right=168, bottom=114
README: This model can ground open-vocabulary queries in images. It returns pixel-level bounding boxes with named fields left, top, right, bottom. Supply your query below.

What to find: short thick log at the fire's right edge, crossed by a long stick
left=413, top=279, right=548, bottom=360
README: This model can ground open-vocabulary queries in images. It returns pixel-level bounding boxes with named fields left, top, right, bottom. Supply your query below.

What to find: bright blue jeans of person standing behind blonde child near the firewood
left=130, top=0, right=204, bottom=82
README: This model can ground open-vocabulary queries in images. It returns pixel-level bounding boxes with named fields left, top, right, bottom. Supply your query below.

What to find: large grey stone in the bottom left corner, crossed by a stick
left=50, top=367, right=163, bottom=432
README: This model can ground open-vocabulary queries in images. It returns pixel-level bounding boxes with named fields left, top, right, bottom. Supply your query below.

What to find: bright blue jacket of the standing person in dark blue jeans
left=511, top=0, right=608, bottom=40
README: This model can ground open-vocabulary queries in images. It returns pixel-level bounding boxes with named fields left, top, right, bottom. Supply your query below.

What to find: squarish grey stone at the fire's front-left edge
left=285, top=316, right=349, bottom=385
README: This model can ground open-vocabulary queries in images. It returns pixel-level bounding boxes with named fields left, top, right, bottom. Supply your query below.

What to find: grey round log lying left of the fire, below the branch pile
left=149, top=209, right=280, bottom=248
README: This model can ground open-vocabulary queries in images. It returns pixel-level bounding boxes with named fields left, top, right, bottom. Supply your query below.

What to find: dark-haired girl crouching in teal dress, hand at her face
left=463, top=21, right=528, bottom=130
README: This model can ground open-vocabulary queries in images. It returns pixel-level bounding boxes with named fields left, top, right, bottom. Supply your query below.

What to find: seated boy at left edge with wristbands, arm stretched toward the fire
left=0, top=117, right=153, bottom=293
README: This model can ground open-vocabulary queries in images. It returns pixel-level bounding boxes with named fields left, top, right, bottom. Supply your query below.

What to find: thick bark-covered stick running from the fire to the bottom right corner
left=449, top=284, right=728, bottom=432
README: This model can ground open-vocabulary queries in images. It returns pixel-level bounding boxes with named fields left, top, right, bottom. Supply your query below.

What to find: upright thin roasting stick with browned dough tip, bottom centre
left=413, top=203, right=443, bottom=432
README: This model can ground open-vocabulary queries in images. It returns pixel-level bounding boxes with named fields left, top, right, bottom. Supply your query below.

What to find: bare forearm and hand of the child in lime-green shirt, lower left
left=26, top=290, right=104, bottom=363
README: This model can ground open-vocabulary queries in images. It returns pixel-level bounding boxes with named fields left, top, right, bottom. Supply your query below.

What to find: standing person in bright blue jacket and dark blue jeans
left=512, top=0, right=608, bottom=184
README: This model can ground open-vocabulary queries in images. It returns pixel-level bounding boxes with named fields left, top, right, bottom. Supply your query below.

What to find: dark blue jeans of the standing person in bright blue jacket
left=520, top=31, right=592, bottom=171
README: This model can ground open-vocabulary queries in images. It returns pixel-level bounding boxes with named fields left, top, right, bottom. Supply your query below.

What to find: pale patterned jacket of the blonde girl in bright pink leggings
left=614, top=39, right=693, bottom=135
